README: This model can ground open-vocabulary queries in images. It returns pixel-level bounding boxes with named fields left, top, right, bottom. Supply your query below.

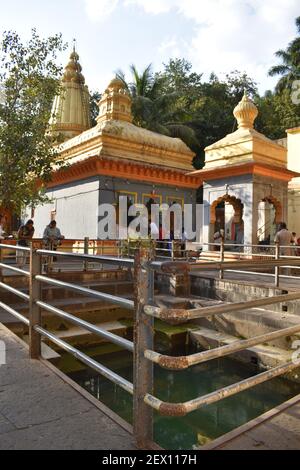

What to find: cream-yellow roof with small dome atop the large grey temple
left=56, top=79, right=194, bottom=171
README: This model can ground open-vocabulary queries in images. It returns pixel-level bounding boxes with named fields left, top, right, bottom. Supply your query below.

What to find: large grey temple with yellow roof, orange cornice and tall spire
left=34, top=52, right=199, bottom=239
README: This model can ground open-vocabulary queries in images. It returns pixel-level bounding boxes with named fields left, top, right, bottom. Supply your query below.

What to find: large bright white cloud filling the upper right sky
left=85, top=0, right=299, bottom=89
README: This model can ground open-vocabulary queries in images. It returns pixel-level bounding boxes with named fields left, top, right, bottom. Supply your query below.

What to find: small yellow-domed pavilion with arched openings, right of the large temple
left=190, top=89, right=297, bottom=245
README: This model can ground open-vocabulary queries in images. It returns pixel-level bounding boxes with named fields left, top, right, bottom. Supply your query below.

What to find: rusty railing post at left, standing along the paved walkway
left=29, top=243, right=42, bottom=359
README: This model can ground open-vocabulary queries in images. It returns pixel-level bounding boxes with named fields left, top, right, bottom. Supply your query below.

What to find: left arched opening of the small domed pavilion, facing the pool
left=210, top=194, right=244, bottom=249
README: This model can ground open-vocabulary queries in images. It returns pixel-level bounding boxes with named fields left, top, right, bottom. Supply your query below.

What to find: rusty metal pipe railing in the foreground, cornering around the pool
left=0, top=244, right=300, bottom=448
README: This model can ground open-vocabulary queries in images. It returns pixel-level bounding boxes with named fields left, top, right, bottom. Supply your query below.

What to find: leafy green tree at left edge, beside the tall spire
left=0, top=29, right=66, bottom=213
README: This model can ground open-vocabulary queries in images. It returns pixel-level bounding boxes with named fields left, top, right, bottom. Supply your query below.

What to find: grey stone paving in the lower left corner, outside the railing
left=0, top=323, right=135, bottom=450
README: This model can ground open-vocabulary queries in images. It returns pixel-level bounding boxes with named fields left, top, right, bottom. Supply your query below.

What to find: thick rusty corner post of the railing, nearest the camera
left=133, top=242, right=154, bottom=449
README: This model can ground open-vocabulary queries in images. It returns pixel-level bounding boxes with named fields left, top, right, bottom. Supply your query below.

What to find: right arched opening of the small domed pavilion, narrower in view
left=257, top=196, right=282, bottom=245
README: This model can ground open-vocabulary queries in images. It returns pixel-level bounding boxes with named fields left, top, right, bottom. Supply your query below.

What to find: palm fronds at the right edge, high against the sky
left=269, top=16, right=300, bottom=92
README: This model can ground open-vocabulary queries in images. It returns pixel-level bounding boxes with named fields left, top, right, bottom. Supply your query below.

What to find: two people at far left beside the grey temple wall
left=17, top=219, right=65, bottom=268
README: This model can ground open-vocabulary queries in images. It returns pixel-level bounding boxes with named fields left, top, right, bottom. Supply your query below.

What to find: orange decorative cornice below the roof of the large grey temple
left=47, top=157, right=199, bottom=189
